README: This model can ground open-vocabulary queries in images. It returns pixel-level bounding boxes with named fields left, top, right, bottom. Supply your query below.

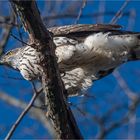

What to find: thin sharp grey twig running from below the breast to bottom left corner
left=5, top=83, right=38, bottom=140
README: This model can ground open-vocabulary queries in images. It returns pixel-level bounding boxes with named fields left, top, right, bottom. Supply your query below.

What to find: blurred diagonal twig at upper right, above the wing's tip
left=110, top=0, right=130, bottom=24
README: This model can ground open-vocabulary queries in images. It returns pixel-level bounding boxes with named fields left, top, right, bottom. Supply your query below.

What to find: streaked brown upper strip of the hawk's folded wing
left=49, top=24, right=121, bottom=36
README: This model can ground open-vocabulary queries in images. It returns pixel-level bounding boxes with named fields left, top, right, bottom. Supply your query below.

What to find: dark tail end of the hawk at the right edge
left=129, top=33, right=140, bottom=61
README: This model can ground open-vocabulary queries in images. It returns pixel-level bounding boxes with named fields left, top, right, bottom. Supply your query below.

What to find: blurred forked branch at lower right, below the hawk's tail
left=94, top=70, right=140, bottom=139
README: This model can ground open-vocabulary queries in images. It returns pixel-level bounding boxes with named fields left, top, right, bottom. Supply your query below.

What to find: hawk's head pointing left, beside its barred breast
left=0, top=48, right=21, bottom=69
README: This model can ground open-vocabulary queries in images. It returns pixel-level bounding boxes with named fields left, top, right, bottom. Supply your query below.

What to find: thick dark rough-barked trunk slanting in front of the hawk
left=11, top=0, right=82, bottom=139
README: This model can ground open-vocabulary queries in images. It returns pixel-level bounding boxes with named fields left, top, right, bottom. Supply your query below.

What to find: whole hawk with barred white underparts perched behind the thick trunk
left=0, top=24, right=140, bottom=95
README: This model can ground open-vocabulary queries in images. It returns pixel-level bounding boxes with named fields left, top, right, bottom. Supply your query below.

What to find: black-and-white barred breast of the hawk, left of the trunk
left=18, top=46, right=43, bottom=80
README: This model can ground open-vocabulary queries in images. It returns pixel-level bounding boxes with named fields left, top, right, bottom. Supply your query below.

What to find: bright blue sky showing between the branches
left=0, top=0, right=140, bottom=139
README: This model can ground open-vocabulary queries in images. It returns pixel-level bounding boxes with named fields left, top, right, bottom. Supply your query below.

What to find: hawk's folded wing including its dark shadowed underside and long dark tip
left=48, top=24, right=139, bottom=42
